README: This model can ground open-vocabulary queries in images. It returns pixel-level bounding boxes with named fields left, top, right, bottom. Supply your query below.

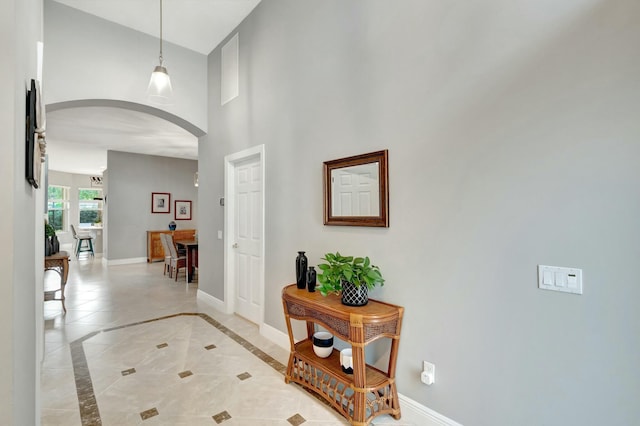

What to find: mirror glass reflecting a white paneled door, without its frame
left=331, top=162, right=380, bottom=216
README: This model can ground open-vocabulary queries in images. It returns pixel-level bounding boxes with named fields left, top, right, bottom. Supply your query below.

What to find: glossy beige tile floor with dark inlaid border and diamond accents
left=41, top=257, right=410, bottom=426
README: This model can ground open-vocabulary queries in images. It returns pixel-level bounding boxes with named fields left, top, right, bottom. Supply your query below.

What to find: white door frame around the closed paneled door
left=224, top=145, right=266, bottom=326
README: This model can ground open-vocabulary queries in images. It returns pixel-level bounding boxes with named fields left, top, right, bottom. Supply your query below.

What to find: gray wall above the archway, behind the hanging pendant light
left=44, top=0, right=207, bottom=131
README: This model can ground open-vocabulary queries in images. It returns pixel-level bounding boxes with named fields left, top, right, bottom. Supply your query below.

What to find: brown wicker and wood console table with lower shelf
left=282, top=284, right=404, bottom=426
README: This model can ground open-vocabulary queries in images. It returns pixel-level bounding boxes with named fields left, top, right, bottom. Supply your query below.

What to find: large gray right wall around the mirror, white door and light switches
left=199, top=0, right=640, bottom=426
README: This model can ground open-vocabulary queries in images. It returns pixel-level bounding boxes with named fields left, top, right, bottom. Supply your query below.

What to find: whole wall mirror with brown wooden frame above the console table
left=323, top=149, right=389, bottom=228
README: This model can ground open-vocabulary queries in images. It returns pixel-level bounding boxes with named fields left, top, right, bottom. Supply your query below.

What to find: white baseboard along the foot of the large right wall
left=258, top=322, right=462, bottom=426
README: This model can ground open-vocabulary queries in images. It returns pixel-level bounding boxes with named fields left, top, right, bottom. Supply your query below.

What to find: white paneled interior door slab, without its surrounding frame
left=229, top=156, right=264, bottom=324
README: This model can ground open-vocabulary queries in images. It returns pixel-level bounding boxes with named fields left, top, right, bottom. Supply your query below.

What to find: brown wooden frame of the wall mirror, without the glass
left=323, top=149, right=389, bottom=228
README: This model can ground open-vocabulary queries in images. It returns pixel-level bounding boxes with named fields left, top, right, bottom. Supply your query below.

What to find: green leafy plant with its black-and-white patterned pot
left=318, top=252, right=384, bottom=306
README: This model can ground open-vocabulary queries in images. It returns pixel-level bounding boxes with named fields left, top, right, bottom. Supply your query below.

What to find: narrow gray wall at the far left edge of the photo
left=0, top=0, right=44, bottom=425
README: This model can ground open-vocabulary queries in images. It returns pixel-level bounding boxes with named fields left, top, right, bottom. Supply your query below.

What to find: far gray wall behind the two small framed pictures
left=104, top=151, right=198, bottom=261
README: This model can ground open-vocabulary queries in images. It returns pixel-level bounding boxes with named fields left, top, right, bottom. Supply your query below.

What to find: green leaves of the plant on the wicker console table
left=318, top=252, right=384, bottom=296
